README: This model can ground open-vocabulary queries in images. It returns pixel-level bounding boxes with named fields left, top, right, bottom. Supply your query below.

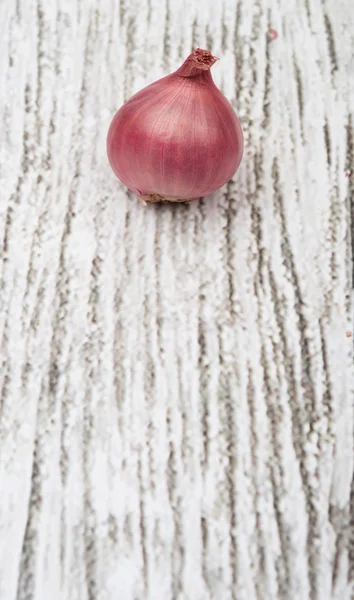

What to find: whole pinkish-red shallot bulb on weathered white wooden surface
left=107, top=48, right=243, bottom=204
